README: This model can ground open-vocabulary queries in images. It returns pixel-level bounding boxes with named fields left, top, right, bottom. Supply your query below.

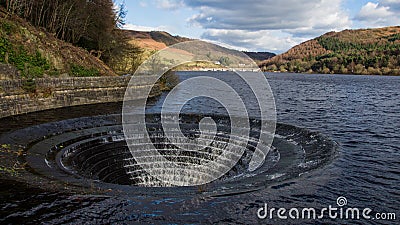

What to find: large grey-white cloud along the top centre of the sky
left=185, top=0, right=351, bottom=35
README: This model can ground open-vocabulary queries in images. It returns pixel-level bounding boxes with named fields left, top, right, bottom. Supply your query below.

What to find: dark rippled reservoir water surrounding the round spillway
left=0, top=73, right=400, bottom=224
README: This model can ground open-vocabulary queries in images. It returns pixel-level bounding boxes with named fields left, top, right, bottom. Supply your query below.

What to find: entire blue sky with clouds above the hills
left=116, top=0, right=400, bottom=53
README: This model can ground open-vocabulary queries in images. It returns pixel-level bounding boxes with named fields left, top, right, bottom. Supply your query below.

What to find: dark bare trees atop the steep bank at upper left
left=0, top=0, right=138, bottom=72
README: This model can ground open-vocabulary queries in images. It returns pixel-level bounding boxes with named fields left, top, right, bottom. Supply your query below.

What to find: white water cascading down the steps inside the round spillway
left=122, top=115, right=269, bottom=186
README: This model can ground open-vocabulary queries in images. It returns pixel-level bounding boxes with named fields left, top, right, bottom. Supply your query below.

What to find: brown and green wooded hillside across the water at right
left=259, top=26, right=400, bottom=75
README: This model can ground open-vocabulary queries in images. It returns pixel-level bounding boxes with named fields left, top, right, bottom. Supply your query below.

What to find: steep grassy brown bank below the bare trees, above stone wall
left=0, top=7, right=116, bottom=79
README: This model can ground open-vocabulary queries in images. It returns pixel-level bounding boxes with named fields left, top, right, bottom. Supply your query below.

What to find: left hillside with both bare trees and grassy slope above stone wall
left=0, top=0, right=139, bottom=77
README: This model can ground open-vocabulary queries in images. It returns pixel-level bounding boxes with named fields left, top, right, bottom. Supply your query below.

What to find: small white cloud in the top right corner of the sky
left=355, top=0, right=400, bottom=27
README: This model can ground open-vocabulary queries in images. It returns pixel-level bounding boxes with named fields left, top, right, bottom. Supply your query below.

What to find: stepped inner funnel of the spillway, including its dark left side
left=60, top=114, right=277, bottom=186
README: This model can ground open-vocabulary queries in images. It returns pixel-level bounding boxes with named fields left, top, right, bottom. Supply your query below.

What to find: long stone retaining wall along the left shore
left=0, top=76, right=161, bottom=118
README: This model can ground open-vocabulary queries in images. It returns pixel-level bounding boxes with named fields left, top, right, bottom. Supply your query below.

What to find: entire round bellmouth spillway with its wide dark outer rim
left=1, top=114, right=338, bottom=195
